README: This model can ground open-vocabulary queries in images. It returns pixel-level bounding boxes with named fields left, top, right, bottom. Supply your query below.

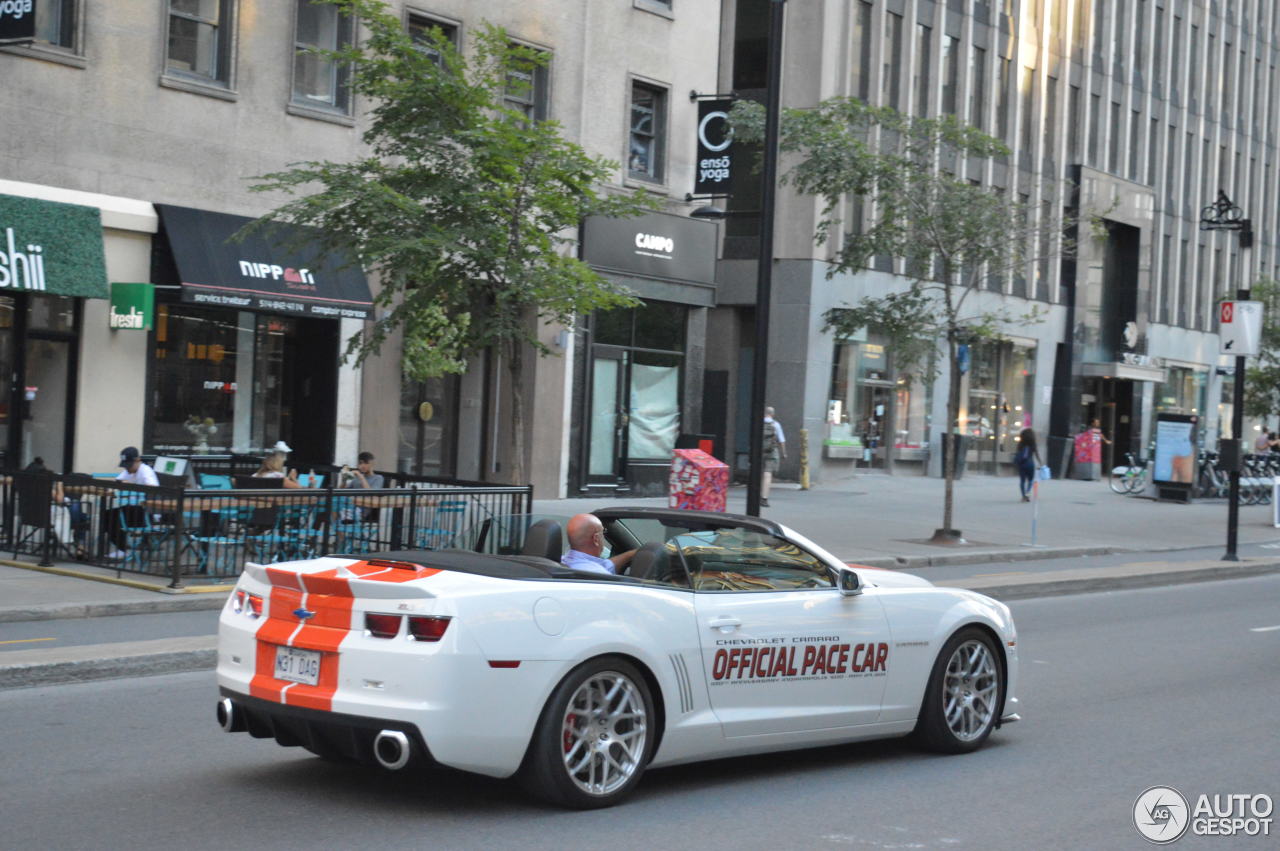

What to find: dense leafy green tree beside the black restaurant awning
left=245, top=0, right=654, bottom=482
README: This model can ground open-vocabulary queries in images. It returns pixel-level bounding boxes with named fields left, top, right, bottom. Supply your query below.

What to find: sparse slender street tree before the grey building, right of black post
left=732, top=97, right=1070, bottom=541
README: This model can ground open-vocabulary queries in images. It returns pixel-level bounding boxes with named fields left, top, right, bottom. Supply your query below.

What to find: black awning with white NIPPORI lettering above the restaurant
left=156, top=203, right=372, bottom=319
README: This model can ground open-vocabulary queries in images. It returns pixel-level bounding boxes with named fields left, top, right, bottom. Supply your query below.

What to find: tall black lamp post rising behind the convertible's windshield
left=746, top=0, right=786, bottom=517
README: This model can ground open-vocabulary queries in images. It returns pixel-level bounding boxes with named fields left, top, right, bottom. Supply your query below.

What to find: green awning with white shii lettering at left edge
left=0, top=195, right=108, bottom=298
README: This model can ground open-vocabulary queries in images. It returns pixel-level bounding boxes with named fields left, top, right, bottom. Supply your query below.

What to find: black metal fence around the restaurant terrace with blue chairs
left=0, top=467, right=532, bottom=586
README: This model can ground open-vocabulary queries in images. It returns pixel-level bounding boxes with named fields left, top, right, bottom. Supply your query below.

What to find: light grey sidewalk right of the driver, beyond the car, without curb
left=534, top=473, right=1280, bottom=567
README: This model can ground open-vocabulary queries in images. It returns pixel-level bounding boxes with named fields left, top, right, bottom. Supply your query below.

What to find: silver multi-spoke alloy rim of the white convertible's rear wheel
left=561, top=671, right=649, bottom=795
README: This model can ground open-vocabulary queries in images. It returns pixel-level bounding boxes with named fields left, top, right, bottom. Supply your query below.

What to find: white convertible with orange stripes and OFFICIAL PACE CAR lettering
left=218, top=508, right=1018, bottom=807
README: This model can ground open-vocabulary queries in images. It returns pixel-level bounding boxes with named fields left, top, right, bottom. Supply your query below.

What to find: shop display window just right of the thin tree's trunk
left=959, top=342, right=1047, bottom=461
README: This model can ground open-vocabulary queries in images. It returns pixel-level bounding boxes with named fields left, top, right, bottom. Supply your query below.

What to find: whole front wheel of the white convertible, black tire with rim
left=915, top=627, right=1005, bottom=754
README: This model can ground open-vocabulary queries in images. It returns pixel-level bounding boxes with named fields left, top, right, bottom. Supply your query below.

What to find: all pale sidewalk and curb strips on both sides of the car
left=0, top=475, right=1280, bottom=688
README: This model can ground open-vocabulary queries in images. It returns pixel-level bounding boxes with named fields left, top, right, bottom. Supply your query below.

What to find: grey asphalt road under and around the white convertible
left=0, top=576, right=1280, bottom=851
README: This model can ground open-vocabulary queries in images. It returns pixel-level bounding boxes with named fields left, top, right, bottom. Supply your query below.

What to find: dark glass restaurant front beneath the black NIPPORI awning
left=143, top=296, right=337, bottom=462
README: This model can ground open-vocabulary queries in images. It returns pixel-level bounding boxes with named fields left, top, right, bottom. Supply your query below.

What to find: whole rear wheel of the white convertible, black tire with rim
left=518, top=656, right=658, bottom=810
